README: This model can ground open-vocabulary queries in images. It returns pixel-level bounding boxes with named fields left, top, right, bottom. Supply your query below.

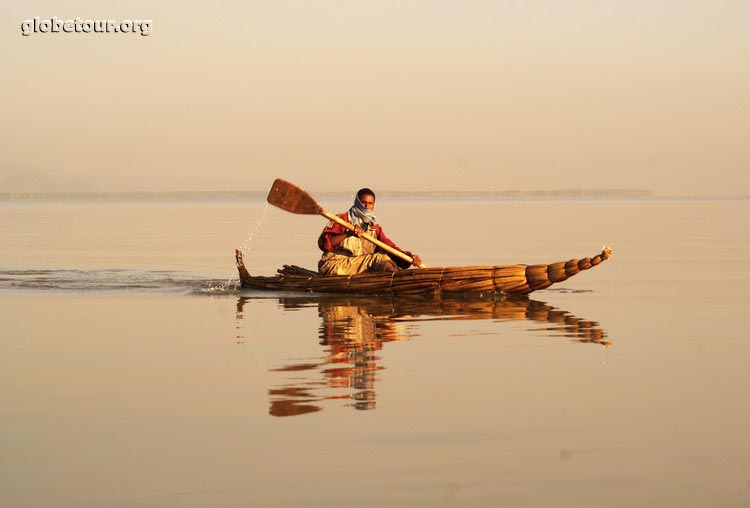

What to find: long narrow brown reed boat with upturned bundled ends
left=235, top=246, right=612, bottom=295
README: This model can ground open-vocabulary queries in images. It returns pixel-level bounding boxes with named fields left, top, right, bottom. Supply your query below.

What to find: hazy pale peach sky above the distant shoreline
left=0, top=0, right=750, bottom=194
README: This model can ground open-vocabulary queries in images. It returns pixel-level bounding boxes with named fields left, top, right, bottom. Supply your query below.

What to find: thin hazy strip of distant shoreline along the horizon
left=0, top=189, right=750, bottom=202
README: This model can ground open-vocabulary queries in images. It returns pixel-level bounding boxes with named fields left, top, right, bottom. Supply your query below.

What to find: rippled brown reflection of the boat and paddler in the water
left=237, top=295, right=611, bottom=416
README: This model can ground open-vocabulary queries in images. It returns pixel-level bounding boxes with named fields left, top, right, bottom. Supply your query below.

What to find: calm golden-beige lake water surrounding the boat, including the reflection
left=0, top=199, right=750, bottom=508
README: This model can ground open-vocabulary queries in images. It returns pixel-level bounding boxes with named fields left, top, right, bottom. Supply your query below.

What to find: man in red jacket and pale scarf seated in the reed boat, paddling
left=318, top=188, right=422, bottom=275
